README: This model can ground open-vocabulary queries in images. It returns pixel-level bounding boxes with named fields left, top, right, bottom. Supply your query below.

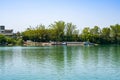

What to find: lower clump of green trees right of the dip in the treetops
left=81, top=24, right=120, bottom=44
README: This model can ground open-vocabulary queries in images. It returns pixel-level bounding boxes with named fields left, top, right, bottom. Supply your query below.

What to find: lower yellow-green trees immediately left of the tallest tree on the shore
left=22, top=24, right=49, bottom=42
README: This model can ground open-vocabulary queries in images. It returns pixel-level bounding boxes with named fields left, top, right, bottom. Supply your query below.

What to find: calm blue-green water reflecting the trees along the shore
left=0, top=45, right=120, bottom=80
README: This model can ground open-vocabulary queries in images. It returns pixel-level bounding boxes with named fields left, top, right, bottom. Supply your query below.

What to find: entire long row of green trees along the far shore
left=22, top=21, right=120, bottom=44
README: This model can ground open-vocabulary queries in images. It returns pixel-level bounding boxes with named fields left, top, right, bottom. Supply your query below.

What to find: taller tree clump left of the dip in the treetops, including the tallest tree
left=22, top=21, right=80, bottom=42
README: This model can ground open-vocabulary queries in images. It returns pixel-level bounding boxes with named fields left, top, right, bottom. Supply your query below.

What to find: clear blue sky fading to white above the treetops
left=0, top=0, right=120, bottom=32
